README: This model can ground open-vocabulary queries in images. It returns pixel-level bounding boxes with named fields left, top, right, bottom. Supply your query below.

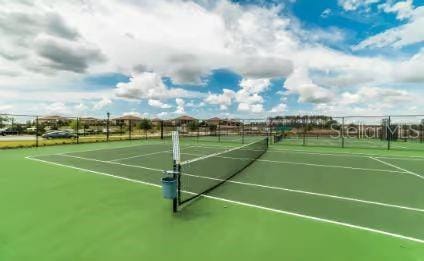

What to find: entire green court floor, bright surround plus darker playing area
left=0, top=137, right=424, bottom=261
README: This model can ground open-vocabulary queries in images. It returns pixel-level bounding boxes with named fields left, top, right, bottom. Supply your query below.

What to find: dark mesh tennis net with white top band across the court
left=178, top=138, right=268, bottom=205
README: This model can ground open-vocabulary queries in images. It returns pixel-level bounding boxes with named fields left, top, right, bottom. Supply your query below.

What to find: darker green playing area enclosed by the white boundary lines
left=28, top=138, right=424, bottom=243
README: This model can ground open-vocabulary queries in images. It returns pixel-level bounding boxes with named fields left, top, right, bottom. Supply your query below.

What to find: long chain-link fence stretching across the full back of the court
left=0, top=114, right=424, bottom=150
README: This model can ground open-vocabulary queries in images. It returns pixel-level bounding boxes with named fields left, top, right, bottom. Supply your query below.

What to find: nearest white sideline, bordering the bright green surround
left=26, top=156, right=424, bottom=244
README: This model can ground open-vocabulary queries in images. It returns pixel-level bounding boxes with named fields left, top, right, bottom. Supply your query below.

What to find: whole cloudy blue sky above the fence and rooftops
left=0, top=0, right=424, bottom=118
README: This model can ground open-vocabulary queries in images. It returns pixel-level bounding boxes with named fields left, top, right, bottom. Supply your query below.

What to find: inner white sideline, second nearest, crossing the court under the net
left=37, top=155, right=424, bottom=212
